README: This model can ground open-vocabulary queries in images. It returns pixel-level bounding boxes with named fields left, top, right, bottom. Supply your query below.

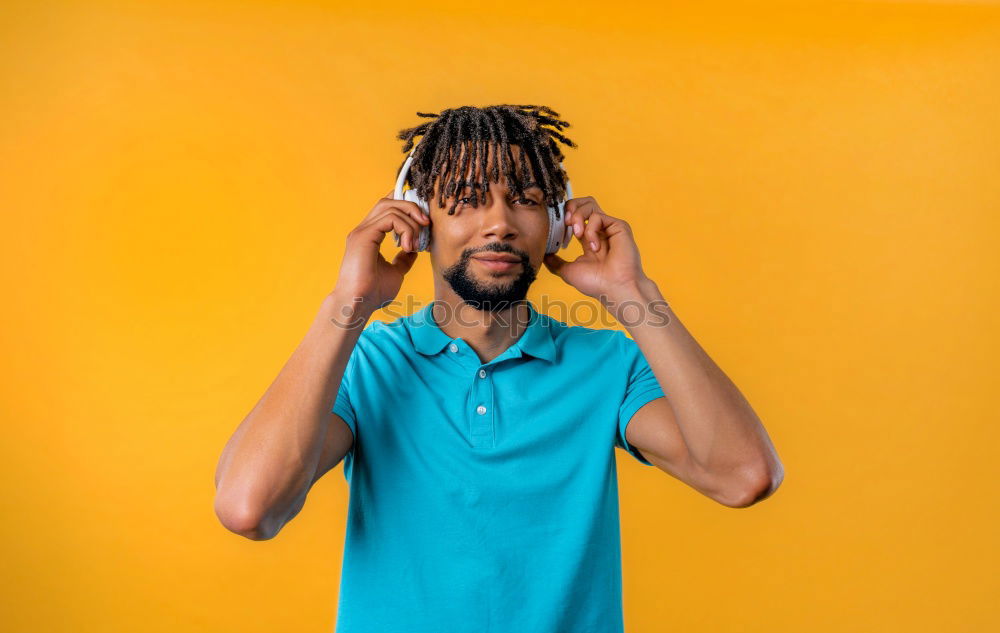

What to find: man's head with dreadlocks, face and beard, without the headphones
left=397, top=105, right=576, bottom=311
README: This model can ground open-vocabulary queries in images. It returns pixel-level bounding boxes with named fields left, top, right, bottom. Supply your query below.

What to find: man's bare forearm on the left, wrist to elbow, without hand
left=215, top=293, right=371, bottom=538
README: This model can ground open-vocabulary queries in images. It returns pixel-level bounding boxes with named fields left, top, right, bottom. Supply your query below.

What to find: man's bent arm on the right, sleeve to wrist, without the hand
left=606, top=278, right=784, bottom=508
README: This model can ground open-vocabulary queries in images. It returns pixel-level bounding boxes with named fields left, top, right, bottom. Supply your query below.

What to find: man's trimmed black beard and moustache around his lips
left=442, top=243, right=537, bottom=312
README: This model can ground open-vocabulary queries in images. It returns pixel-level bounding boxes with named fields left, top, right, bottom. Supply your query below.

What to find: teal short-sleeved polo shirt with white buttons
left=333, top=301, right=664, bottom=633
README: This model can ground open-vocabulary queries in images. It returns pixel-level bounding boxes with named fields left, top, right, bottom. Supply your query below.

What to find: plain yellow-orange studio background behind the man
left=0, top=1, right=1000, bottom=633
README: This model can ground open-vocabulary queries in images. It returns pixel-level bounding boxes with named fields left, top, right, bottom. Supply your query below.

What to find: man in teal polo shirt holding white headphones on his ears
left=216, top=105, right=783, bottom=633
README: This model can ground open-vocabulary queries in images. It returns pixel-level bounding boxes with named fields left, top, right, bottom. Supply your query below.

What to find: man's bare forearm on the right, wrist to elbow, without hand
left=605, top=278, right=781, bottom=487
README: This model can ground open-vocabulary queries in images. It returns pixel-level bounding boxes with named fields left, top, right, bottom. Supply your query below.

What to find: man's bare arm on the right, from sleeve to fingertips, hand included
left=544, top=196, right=784, bottom=508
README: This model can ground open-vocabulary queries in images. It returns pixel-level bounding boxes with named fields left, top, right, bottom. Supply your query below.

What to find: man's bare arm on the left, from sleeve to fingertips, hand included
left=215, top=190, right=430, bottom=540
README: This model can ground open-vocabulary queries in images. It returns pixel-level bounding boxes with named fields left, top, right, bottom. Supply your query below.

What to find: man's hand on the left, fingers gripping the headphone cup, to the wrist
left=333, top=191, right=430, bottom=312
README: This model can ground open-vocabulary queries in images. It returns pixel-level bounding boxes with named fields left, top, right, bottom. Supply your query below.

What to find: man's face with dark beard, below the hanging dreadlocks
left=430, top=145, right=549, bottom=312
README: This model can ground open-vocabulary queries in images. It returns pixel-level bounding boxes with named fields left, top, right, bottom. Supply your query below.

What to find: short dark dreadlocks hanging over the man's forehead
left=396, top=104, right=576, bottom=215
